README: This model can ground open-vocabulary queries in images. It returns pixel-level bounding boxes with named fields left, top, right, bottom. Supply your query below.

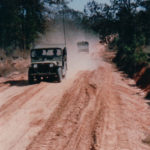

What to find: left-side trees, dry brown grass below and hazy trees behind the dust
left=0, top=0, right=83, bottom=76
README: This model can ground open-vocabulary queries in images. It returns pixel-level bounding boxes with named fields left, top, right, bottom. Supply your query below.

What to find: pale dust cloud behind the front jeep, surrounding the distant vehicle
left=35, top=24, right=99, bottom=78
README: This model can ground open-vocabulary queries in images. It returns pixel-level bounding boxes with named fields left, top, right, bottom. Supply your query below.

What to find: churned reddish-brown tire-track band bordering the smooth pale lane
left=27, top=72, right=99, bottom=150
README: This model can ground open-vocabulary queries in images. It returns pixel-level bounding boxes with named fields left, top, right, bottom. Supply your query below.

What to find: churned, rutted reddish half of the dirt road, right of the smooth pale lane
left=27, top=65, right=150, bottom=150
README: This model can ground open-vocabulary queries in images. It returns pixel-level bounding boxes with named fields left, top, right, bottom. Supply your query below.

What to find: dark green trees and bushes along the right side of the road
left=83, top=0, right=150, bottom=76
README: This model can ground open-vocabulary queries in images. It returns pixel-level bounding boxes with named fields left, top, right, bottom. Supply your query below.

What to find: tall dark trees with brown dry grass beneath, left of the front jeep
left=0, top=0, right=46, bottom=76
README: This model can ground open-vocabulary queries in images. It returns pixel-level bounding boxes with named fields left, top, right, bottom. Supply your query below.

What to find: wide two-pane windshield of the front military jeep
left=31, top=48, right=62, bottom=62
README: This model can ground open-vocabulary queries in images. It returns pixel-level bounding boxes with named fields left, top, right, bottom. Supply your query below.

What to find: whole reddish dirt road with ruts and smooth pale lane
left=0, top=42, right=150, bottom=150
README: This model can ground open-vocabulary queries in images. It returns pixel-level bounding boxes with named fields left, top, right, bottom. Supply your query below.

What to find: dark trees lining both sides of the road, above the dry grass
left=0, top=0, right=150, bottom=83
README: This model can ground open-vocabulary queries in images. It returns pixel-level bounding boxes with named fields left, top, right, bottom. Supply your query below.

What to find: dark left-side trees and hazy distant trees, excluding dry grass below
left=0, top=0, right=82, bottom=52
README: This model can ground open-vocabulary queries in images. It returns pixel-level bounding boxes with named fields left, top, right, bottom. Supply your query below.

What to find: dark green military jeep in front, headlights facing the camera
left=28, top=47, right=67, bottom=84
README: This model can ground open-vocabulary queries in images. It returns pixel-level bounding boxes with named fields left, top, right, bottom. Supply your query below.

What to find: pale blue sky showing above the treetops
left=69, top=0, right=109, bottom=11
